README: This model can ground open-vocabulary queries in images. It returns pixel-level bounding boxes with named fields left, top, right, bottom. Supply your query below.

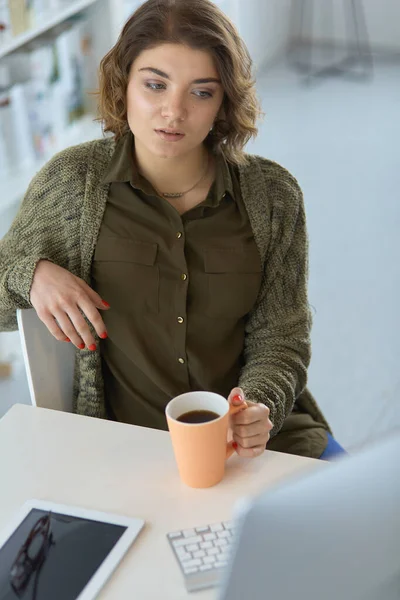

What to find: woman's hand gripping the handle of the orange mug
left=228, top=388, right=273, bottom=458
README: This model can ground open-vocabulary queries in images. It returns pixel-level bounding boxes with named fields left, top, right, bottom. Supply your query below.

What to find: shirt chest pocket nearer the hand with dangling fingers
left=93, top=237, right=159, bottom=313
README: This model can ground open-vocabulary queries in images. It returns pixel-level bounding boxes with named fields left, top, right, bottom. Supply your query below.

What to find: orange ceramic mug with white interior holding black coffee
left=165, top=392, right=247, bottom=488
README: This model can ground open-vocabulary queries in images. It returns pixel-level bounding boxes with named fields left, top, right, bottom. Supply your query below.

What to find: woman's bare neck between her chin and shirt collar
left=135, top=140, right=207, bottom=192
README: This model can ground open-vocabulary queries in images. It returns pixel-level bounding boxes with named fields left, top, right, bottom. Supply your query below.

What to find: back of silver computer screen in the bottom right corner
left=217, top=432, right=400, bottom=600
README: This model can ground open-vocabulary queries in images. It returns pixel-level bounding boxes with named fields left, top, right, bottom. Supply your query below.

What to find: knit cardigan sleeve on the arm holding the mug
left=239, top=177, right=311, bottom=436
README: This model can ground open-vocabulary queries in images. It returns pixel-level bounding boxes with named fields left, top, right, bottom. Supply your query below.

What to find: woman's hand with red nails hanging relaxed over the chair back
left=30, top=260, right=109, bottom=350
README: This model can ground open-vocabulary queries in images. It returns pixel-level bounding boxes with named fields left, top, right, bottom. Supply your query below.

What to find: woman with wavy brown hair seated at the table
left=0, top=0, right=340, bottom=457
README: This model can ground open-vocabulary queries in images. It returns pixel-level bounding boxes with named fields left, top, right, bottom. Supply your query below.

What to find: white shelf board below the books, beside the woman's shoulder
left=0, top=115, right=102, bottom=215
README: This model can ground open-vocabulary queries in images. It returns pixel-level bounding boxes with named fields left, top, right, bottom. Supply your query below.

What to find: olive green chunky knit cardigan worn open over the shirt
left=0, top=138, right=329, bottom=436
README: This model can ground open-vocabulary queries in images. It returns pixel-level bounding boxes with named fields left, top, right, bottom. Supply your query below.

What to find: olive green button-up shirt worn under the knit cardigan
left=92, top=134, right=262, bottom=429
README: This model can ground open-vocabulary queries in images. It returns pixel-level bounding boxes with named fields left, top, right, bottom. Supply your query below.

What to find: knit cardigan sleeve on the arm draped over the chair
left=0, top=146, right=90, bottom=331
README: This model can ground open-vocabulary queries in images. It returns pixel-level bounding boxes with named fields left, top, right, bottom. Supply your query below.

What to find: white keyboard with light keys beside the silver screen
left=167, top=521, right=234, bottom=592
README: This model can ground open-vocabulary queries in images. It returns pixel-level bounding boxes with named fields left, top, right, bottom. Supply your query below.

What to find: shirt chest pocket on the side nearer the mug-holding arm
left=204, top=244, right=261, bottom=319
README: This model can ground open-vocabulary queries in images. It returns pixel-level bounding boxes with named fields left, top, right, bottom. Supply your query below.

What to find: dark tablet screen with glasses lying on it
left=0, top=509, right=127, bottom=600
